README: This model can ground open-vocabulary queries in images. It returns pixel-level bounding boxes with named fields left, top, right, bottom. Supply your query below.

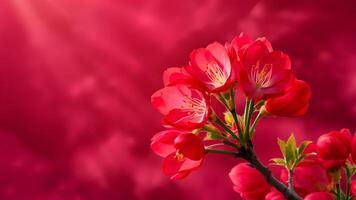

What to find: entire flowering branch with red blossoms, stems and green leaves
left=151, top=33, right=356, bottom=200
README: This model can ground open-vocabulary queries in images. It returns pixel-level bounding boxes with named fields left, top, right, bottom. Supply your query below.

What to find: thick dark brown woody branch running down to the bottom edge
left=236, top=149, right=303, bottom=200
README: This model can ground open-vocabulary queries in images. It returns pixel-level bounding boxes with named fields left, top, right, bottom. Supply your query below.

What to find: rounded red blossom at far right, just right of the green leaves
left=317, top=129, right=352, bottom=169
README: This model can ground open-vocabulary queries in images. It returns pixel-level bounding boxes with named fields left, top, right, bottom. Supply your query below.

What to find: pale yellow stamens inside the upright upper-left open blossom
left=205, top=61, right=226, bottom=88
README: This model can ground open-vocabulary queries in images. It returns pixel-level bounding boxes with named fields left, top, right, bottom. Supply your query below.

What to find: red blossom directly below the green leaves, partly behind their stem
left=281, top=161, right=330, bottom=197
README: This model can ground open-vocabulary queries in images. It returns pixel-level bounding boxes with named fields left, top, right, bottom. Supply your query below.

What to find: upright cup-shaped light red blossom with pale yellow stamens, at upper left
left=186, top=42, right=233, bottom=92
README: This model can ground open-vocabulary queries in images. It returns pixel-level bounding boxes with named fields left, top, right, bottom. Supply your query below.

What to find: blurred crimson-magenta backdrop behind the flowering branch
left=0, top=0, right=356, bottom=200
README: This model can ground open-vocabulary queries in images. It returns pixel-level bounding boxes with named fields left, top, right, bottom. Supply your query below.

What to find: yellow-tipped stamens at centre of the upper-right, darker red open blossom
left=251, top=62, right=273, bottom=88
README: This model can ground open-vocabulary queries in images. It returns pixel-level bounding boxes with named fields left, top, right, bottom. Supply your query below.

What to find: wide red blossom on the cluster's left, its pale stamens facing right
left=151, top=84, right=210, bottom=129
